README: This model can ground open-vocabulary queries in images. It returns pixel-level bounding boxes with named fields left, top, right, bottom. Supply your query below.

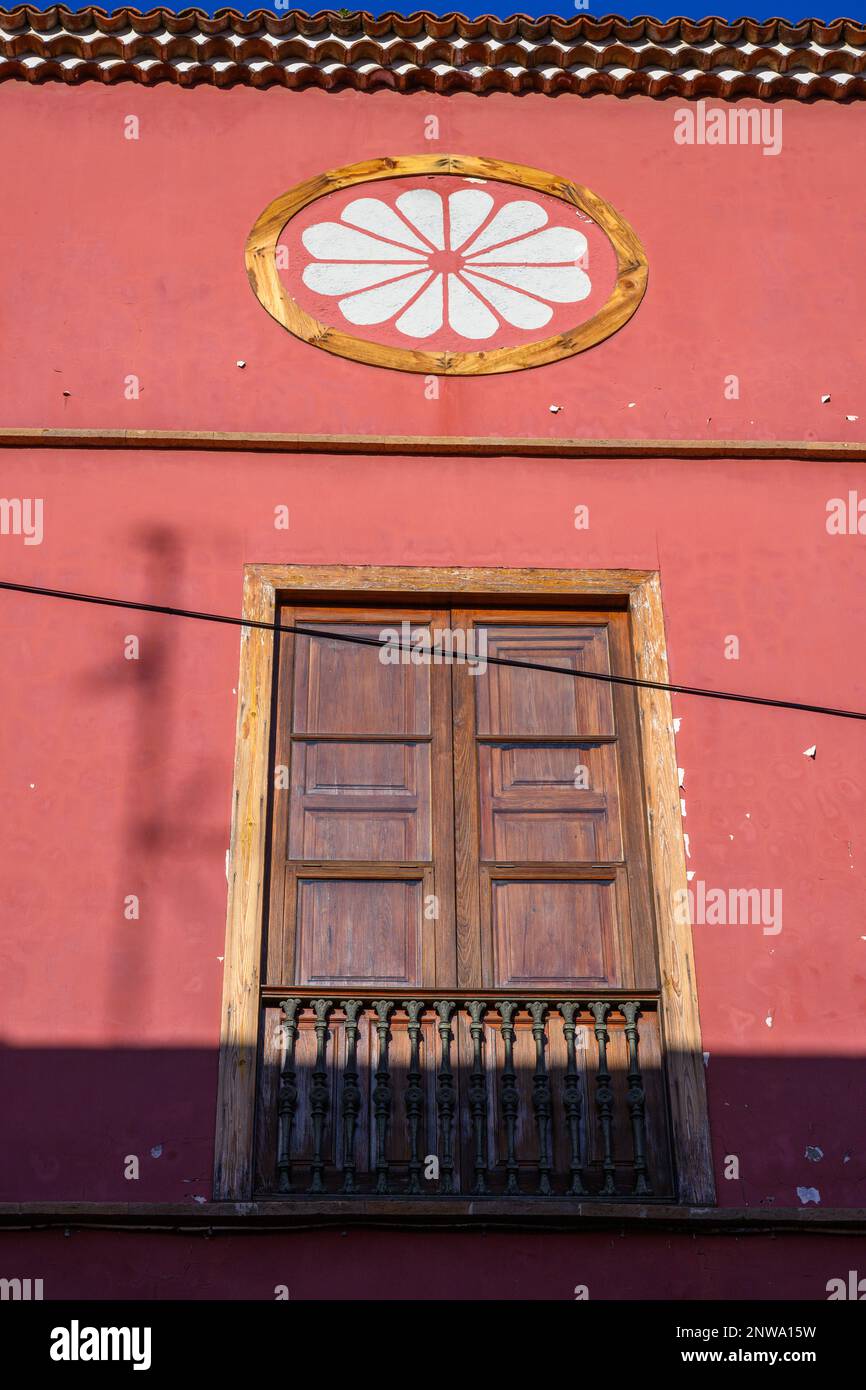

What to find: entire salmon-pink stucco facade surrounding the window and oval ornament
left=0, top=10, right=866, bottom=1298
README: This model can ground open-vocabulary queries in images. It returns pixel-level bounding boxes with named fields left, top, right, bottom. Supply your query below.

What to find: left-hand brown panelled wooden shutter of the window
left=267, top=607, right=456, bottom=990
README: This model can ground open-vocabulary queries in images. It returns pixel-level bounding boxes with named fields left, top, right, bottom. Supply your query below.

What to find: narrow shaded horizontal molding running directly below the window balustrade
left=0, top=1197, right=866, bottom=1237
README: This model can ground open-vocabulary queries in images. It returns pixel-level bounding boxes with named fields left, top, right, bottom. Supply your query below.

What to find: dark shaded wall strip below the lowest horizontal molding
left=0, top=1230, right=863, bottom=1301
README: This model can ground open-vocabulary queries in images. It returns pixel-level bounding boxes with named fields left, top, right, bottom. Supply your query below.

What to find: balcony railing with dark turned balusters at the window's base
left=259, top=994, right=673, bottom=1200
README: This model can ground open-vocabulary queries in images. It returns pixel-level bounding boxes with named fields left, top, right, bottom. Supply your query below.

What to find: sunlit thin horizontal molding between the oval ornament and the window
left=0, top=427, right=866, bottom=463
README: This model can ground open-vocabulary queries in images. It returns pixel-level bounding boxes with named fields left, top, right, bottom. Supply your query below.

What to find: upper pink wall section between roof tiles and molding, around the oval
left=0, top=83, right=866, bottom=439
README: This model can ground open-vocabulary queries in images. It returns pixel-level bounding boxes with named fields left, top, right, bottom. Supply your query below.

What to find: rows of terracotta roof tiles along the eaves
left=0, top=6, right=866, bottom=100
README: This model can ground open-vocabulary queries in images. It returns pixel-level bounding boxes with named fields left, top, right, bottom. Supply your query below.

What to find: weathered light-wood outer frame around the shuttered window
left=214, top=564, right=716, bottom=1207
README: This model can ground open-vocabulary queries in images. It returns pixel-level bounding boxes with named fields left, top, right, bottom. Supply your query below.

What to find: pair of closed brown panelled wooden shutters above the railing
left=267, top=607, right=659, bottom=992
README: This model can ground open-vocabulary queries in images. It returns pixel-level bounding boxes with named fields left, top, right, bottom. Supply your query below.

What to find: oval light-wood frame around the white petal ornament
left=240, top=154, right=649, bottom=377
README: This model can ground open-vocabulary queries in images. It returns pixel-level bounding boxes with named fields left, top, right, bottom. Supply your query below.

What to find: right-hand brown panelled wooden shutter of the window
left=452, top=610, right=657, bottom=992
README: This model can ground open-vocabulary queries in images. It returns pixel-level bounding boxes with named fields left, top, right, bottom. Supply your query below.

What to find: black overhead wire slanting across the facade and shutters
left=0, top=580, right=866, bottom=720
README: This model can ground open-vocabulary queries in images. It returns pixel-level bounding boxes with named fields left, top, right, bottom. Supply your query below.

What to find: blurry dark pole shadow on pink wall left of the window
left=75, top=523, right=229, bottom=1040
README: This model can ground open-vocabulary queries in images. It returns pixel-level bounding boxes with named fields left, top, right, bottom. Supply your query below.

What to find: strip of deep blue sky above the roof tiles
left=35, top=0, right=866, bottom=21
